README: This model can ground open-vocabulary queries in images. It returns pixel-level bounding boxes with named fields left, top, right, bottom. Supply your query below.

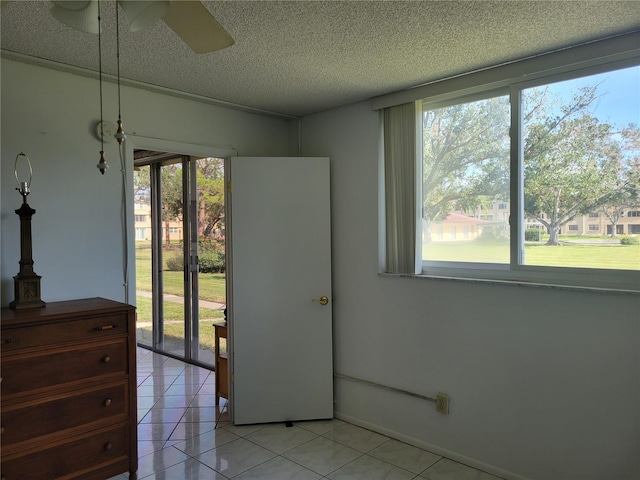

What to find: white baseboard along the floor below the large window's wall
left=334, top=411, right=531, bottom=480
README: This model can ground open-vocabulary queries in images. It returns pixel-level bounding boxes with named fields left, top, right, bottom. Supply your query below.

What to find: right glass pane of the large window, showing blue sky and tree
left=522, top=67, right=640, bottom=270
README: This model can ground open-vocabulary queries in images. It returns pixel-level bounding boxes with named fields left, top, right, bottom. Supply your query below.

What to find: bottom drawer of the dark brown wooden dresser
left=1, top=423, right=129, bottom=480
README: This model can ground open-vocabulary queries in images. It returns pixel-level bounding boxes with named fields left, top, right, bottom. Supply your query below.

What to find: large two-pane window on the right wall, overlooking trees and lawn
left=417, top=64, right=640, bottom=289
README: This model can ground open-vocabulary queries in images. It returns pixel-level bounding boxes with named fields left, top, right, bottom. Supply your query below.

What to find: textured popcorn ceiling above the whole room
left=0, top=0, right=640, bottom=116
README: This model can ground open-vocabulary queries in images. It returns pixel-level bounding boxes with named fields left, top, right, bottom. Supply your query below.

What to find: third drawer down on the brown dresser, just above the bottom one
left=1, top=380, right=129, bottom=453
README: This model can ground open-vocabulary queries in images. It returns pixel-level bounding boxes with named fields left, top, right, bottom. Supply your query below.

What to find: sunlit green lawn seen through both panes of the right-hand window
left=423, top=238, right=640, bottom=270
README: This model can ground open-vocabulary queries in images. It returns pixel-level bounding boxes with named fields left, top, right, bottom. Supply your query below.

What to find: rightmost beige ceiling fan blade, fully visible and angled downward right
left=162, top=0, right=235, bottom=53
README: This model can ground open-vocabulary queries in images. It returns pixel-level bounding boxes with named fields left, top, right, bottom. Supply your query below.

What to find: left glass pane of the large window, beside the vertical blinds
left=422, top=96, right=510, bottom=263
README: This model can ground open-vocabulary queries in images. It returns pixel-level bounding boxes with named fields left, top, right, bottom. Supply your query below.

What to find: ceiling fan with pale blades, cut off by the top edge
left=51, top=0, right=235, bottom=53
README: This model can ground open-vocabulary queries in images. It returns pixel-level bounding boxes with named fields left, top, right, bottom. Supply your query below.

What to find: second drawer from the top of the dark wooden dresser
left=2, top=338, right=129, bottom=401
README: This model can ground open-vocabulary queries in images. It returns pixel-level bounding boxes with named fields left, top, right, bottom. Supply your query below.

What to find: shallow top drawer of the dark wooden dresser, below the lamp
left=0, top=312, right=128, bottom=352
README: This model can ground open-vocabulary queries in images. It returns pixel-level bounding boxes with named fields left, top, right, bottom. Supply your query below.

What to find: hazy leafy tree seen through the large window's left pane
left=422, top=96, right=509, bottom=240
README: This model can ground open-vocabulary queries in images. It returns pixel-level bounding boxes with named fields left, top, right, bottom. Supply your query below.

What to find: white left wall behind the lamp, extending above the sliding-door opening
left=0, top=59, right=297, bottom=306
